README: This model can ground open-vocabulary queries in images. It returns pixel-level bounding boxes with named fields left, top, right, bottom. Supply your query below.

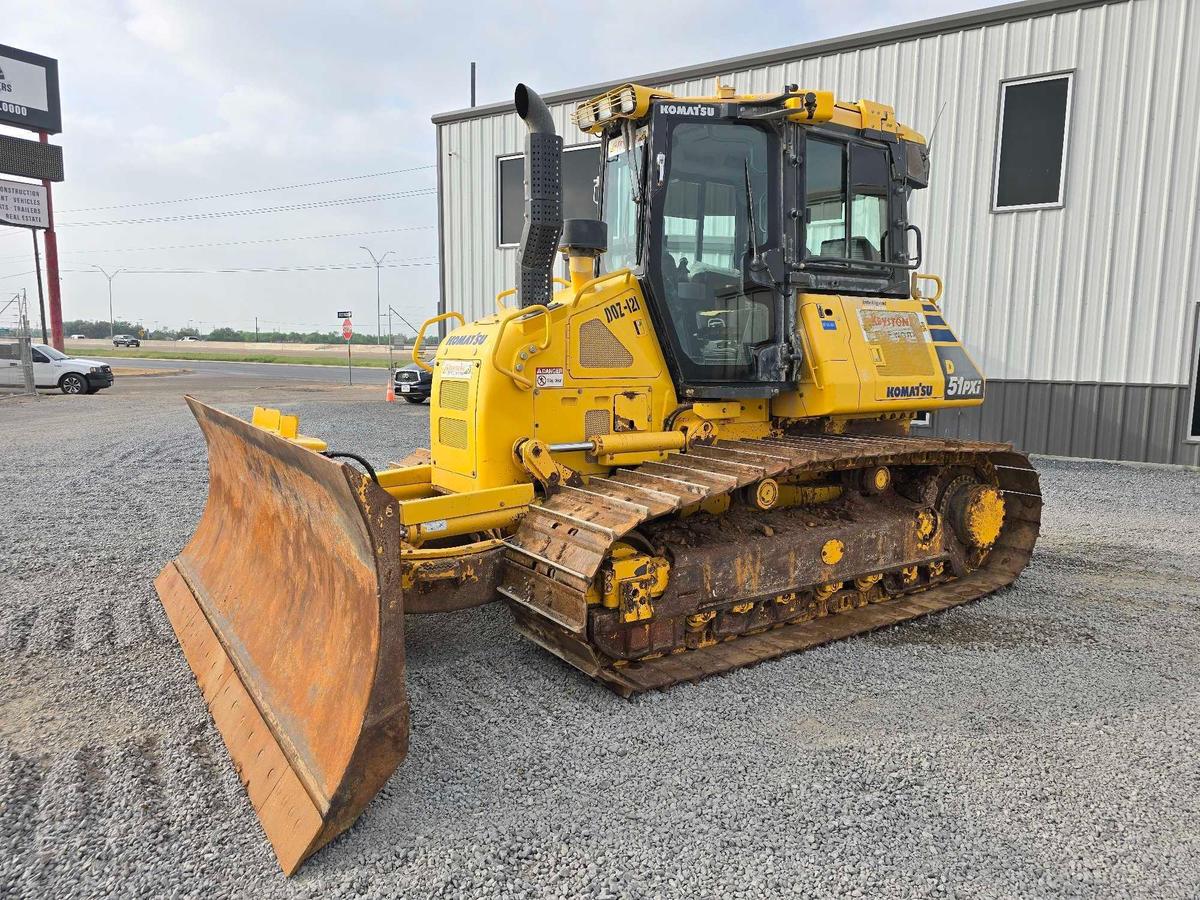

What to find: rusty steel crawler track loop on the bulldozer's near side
left=499, top=434, right=1042, bottom=696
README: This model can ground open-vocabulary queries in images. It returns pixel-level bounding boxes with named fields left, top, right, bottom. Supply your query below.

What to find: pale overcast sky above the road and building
left=0, top=0, right=991, bottom=338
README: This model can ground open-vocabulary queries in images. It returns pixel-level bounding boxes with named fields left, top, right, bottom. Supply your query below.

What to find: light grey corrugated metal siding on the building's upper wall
left=439, top=0, right=1200, bottom=384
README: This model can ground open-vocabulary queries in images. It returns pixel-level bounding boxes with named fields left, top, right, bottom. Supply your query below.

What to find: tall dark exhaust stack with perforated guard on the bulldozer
left=514, top=84, right=563, bottom=307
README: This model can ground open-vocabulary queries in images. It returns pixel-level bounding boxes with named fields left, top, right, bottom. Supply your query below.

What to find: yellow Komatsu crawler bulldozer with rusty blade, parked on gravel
left=156, top=84, right=1042, bottom=874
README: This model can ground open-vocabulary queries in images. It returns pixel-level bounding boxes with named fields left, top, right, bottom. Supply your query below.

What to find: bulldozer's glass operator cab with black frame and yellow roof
left=576, top=85, right=928, bottom=398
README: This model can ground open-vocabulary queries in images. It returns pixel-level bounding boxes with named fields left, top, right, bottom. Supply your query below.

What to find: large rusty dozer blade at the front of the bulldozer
left=155, top=397, right=408, bottom=875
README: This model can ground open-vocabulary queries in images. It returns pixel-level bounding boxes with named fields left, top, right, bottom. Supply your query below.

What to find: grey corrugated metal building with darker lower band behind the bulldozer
left=433, top=0, right=1200, bottom=466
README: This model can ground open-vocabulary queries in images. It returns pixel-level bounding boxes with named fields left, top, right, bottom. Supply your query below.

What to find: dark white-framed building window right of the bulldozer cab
left=992, top=72, right=1072, bottom=211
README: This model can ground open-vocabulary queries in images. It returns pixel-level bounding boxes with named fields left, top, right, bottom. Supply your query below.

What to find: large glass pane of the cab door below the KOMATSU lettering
left=655, top=121, right=778, bottom=382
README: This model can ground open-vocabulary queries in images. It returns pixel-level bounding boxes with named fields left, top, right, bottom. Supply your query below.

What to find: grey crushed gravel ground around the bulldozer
left=0, top=376, right=1200, bottom=898
